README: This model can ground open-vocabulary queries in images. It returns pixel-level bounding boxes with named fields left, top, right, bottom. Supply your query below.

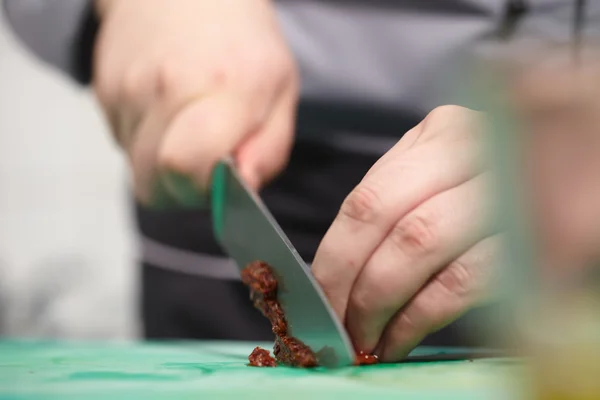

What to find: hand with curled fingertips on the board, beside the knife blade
left=312, top=106, right=499, bottom=361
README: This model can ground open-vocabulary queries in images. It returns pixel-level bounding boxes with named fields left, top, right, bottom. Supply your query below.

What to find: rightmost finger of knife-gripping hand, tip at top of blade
left=235, top=79, right=298, bottom=190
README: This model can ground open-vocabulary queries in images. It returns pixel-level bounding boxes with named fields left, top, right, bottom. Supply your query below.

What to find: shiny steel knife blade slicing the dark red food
left=211, top=159, right=355, bottom=367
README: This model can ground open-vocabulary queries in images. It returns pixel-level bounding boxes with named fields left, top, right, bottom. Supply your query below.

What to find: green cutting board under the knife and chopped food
left=0, top=341, right=523, bottom=400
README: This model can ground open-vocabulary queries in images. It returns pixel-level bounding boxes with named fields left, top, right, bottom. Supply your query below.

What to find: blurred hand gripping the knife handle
left=94, top=0, right=298, bottom=206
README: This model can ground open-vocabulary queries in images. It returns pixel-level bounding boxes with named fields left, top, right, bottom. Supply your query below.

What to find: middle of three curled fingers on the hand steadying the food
left=346, top=173, right=492, bottom=351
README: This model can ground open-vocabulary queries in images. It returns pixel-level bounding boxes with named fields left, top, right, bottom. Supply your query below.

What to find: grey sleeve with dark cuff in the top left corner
left=4, top=0, right=98, bottom=83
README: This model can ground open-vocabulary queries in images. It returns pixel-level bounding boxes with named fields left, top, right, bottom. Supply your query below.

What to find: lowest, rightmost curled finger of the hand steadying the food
left=376, top=235, right=501, bottom=362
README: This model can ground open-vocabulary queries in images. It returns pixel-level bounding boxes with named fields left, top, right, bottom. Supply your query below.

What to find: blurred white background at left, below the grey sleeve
left=0, top=14, right=137, bottom=339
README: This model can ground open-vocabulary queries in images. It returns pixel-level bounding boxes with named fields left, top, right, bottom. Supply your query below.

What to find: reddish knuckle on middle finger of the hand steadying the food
left=390, top=215, right=440, bottom=256
